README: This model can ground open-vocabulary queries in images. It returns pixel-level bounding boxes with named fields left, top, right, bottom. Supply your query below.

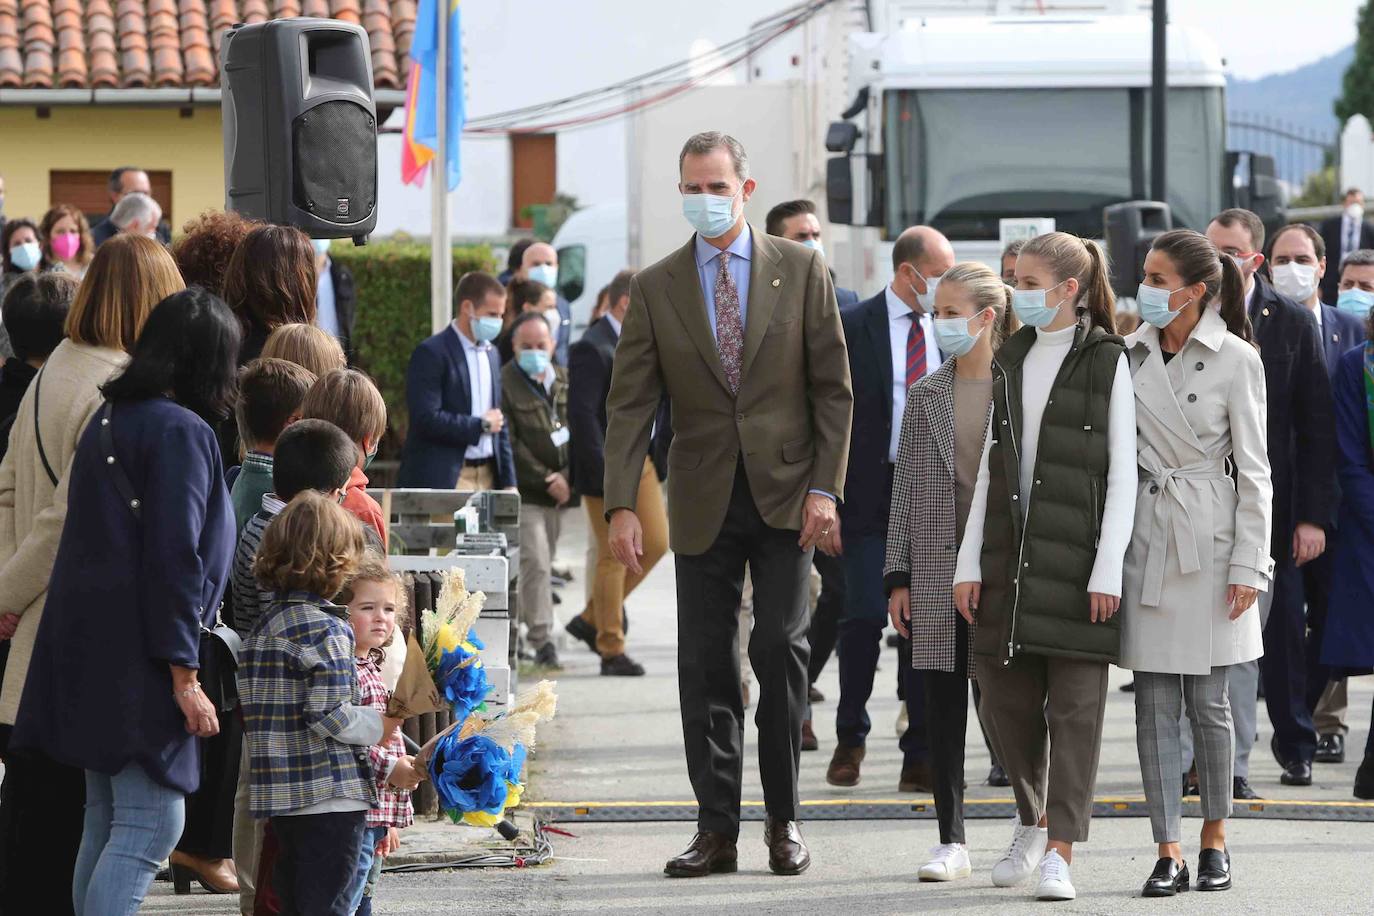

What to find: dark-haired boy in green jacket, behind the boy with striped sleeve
left=229, top=360, right=315, bottom=533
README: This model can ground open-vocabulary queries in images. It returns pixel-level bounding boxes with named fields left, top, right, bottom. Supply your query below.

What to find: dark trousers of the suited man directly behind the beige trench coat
left=1260, top=560, right=1316, bottom=764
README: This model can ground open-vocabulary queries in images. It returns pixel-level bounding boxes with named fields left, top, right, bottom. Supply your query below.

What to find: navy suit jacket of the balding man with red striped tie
left=840, top=288, right=901, bottom=534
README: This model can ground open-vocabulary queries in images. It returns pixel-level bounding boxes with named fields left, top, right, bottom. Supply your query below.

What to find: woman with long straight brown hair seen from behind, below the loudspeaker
left=224, top=225, right=316, bottom=365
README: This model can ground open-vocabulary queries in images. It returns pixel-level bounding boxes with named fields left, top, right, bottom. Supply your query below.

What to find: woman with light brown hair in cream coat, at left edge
left=0, top=233, right=183, bottom=915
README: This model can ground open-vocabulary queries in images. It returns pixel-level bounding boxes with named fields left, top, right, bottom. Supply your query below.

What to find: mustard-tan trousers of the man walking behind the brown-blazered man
left=583, top=459, right=668, bottom=658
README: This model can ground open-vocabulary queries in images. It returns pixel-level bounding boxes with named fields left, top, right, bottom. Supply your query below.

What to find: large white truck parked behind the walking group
left=826, top=14, right=1278, bottom=290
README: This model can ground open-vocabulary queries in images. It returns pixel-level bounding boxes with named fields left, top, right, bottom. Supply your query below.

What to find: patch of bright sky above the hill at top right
left=1169, top=0, right=1360, bottom=80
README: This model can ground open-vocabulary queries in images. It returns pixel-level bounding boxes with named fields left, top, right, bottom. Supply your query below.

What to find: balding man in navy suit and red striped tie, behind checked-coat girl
left=826, top=227, right=954, bottom=791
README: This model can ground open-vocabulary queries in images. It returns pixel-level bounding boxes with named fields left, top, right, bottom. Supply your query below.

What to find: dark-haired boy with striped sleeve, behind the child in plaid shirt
left=231, top=420, right=375, bottom=916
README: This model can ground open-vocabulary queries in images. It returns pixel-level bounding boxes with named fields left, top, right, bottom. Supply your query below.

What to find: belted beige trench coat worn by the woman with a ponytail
left=1121, top=309, right=1274, bottom=674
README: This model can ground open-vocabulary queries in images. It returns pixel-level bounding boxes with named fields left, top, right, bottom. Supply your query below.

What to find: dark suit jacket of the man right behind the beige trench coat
left=1250, top=276, right=1337, bottom=541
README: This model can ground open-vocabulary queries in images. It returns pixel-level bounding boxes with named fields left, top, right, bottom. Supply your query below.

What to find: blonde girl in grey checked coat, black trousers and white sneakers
left=883, top=264, right=1014, bottom=882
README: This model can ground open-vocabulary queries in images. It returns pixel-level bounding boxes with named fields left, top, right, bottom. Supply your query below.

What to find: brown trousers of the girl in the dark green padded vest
left=978, top=655, right=1107, bottom=843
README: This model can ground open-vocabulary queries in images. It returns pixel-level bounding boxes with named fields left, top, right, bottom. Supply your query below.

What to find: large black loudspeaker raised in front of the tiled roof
left=220, top=19, right=376, bottom=244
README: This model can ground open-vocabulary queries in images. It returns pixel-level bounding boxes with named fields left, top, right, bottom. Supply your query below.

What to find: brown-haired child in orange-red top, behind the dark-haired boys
left=301, top=369, right=387, bottom=552
